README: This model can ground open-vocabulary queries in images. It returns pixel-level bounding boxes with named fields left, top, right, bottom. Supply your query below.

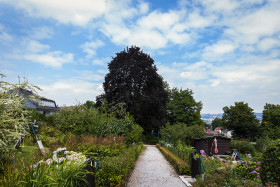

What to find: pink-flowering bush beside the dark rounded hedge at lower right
left=235, top=161, right=261, bottom=182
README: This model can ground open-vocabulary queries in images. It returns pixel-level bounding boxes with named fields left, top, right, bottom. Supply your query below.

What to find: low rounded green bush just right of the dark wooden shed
left=230, top=140, right=255, bottom=155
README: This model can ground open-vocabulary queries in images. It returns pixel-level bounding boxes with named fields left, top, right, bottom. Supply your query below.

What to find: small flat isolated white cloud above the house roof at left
left=24, top=51, right=73, bottom=68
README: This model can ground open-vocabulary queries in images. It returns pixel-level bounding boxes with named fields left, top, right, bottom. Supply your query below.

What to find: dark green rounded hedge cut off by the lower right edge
left=261, top=139, right=280, bottom=186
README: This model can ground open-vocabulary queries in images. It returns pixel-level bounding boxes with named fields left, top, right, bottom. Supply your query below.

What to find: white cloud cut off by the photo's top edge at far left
left=1, top=0, right=107, bottom=26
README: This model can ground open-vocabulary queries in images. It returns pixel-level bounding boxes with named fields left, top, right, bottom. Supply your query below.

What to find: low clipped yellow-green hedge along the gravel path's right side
left=157, top=144, right=190, bottom=175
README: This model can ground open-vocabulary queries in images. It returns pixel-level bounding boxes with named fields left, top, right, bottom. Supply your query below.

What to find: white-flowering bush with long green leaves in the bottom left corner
left=0, top=148, right=90, bottom=186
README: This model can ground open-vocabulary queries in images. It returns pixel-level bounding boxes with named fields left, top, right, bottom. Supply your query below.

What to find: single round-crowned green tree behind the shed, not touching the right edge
left=222, top=102, right=259, bottom=139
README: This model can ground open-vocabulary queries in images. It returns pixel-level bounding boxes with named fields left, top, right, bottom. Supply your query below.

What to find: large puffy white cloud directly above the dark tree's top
left=101, top=10, right=194, bottom=49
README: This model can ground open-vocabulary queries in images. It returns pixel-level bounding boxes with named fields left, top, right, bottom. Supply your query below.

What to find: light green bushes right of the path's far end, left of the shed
left=160, top=123, right=205, bottom=144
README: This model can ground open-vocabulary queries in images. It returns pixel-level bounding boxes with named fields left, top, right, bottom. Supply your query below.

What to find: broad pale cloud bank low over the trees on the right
left=157, top=57, right=280, bottom=112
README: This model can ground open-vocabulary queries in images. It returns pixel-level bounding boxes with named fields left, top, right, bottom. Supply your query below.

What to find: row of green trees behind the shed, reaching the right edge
left=211, top=102, right=280, bottom=140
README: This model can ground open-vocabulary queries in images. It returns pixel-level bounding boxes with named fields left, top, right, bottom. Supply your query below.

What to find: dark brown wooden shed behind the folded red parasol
left=192, top=136, right=231, bottom=156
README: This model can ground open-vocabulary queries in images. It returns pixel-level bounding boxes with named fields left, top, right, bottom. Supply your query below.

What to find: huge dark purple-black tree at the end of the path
left=97, top=46, right=167, bottom=130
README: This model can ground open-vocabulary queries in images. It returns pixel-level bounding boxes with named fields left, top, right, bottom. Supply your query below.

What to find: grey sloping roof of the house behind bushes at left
left=11, top=89, right=60, bottom=111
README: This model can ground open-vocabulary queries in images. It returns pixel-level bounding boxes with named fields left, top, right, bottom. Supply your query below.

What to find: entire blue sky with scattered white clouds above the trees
left=0, top=0, right=280, bottom=113
